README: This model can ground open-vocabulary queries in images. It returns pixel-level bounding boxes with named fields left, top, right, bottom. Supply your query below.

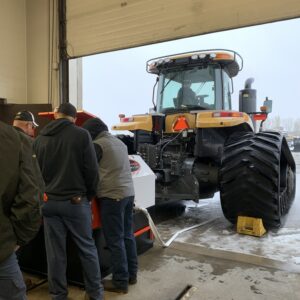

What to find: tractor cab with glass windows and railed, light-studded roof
left=147, top=50, right=242, bottom=114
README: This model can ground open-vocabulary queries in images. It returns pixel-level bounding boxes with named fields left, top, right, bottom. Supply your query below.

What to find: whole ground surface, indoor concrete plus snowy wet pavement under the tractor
left=25, top=154, right=300, bottom=300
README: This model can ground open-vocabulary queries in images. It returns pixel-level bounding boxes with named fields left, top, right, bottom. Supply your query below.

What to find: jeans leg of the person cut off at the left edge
left=0, top=253, right=26, bottom=300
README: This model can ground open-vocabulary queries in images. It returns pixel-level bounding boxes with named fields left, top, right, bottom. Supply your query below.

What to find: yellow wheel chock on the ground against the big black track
left=237, top=216, right=266, bottom=237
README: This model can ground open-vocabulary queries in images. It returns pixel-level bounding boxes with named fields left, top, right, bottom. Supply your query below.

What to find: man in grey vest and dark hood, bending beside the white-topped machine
left=82, top=118, right=138, bottom=293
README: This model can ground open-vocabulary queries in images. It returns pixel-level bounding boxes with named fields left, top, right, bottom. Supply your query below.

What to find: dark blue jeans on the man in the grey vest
left=100, top=196, right=138, bottom=287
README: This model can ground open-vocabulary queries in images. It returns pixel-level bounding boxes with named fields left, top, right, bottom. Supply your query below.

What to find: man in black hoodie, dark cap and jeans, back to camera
left=34, top=103, right=103, bottom=300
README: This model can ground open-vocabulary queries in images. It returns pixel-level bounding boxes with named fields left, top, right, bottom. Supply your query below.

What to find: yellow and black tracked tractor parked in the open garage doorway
left=112, top=50, right=295, bottom=228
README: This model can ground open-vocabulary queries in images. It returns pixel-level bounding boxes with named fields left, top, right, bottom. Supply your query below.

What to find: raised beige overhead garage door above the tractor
left=66, top=0, right=300, bottom=57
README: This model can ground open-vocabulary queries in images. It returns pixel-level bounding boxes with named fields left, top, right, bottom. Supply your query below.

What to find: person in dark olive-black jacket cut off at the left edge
left=0, top=122, right=41, bottom=300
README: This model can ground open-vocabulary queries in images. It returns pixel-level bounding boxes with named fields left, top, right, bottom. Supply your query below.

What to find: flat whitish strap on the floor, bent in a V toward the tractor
left=134, top=207, right=214, bottom=248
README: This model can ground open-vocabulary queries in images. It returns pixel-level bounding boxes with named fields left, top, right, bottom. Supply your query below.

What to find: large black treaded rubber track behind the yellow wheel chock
left=220, top=132, right=296, bottom=228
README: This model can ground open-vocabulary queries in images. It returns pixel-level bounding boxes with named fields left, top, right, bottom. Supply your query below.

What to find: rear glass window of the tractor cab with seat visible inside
left=157, top=66, right=217, bottom=113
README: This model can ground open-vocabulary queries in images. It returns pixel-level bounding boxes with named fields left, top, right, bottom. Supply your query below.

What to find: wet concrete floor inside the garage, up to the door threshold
left=28, top=247, right=300, bottom=300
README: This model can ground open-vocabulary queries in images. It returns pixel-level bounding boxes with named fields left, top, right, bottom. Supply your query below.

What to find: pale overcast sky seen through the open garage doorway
left=83, top=19, right=300, bottom=127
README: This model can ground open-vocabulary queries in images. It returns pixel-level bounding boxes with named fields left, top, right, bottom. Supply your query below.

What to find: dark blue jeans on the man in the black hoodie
left=42, top=199, right=103, bottom=300
